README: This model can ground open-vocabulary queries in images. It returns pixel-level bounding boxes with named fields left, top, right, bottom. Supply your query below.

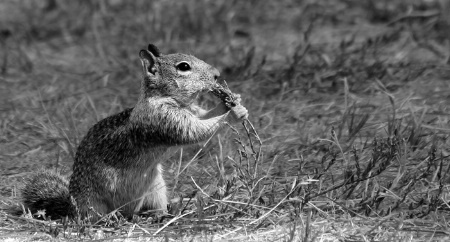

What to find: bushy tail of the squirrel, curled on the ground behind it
left=22, top=171, right=75, bottom=219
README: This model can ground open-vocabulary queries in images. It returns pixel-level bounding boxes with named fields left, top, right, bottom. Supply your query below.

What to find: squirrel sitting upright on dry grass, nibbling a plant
left=22, top=44, right=248, bottom=219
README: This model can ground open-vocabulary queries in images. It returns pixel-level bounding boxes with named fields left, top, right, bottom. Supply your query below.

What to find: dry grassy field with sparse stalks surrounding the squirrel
left=0, top=0, right=450, bottom=241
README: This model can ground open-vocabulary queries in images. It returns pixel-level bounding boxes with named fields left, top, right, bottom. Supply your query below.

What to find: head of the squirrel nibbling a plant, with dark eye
left=139, top=44, right=220, bottom=105
